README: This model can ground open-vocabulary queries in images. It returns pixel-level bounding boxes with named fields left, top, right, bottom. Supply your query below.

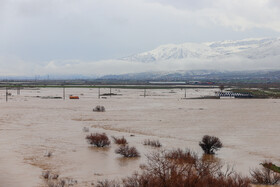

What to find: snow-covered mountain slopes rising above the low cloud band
left=121, top=38, right=280, bottom=63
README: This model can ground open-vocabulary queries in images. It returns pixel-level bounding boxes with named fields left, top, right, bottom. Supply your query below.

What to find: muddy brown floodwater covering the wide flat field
left=0, top=88, right=280, bottom=186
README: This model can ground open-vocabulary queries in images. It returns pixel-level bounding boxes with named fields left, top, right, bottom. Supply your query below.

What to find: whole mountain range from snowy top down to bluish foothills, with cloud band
left=101, top=38, right=280, bottom=81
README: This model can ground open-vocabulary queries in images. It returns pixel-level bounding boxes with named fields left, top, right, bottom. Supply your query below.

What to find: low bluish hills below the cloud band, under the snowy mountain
left=100, top=70, right=280, bottom=82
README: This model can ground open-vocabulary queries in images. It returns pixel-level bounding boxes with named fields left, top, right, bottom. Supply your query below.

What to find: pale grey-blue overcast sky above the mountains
left=0, top=0, right=280, bottom=76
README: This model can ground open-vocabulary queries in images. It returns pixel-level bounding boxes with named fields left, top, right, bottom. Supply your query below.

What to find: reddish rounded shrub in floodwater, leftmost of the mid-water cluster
left=86, top=133, right=111, bottom=147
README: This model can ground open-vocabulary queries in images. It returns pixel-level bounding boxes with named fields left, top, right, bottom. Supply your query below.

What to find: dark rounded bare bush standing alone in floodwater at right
left=199, top=135, right=223, bottom=154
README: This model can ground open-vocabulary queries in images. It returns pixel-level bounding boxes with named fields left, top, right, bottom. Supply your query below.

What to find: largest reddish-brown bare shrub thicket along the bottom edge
left=123, top=149, right=250, bottom=187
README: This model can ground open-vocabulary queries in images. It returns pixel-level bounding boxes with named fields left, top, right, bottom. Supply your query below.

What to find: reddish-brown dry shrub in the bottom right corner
left=250, top=162, right=280, bottom=185
